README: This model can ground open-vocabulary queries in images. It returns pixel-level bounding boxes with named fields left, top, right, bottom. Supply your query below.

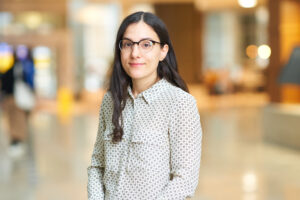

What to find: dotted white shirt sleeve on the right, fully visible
left=157, top=96, right=202, bottom=200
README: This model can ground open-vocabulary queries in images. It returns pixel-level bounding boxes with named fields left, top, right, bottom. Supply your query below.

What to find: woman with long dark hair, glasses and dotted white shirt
left=88, top=12, right=202, bottom=200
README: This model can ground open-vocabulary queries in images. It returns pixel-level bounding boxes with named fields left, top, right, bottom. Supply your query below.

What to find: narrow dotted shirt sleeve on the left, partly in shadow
left=87, top=96, right=106, bottom=200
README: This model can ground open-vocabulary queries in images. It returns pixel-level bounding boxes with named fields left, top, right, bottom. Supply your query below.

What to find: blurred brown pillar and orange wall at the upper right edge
left=267, top=0, right=300, bottom=102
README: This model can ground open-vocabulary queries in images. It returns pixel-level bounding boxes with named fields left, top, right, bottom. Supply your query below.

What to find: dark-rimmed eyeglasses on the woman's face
left=119, top=39, right=162, bottom=53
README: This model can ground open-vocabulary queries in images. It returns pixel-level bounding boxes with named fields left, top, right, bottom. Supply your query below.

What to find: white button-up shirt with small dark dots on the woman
left=88, top=79, right=202, bottom=200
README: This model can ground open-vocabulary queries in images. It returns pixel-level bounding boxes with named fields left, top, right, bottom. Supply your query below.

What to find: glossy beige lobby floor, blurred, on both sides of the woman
left=0, top=90, right=300, bottom=200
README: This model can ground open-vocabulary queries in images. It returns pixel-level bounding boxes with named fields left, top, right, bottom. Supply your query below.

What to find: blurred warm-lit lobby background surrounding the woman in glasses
left=0, top=0, right=300, bottom=200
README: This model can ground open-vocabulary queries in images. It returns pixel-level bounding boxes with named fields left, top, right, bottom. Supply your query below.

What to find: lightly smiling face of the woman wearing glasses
left=121, top=21, right=168, bottom=82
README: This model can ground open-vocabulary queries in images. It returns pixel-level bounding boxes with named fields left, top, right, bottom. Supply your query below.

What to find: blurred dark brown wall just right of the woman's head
left=154, top=3, right=202, bottom=83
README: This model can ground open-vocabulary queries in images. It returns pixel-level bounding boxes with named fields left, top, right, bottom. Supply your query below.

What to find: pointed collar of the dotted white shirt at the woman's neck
left=127, top=78, right=170, bottom=104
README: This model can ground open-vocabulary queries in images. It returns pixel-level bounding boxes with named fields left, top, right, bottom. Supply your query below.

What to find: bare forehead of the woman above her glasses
left=123, top=21, right=159, bottom=41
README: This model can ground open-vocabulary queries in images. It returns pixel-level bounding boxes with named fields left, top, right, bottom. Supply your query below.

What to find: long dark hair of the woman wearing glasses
left=108, top=12, right=188, bottom=143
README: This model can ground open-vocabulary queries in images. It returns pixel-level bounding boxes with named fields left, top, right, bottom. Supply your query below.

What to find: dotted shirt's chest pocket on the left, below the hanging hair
left=103, top=130, right=122, bottom=172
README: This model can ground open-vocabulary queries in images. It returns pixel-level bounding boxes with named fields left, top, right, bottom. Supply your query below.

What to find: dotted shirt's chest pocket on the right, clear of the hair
left=127, top=130, right=170, bottom=171
